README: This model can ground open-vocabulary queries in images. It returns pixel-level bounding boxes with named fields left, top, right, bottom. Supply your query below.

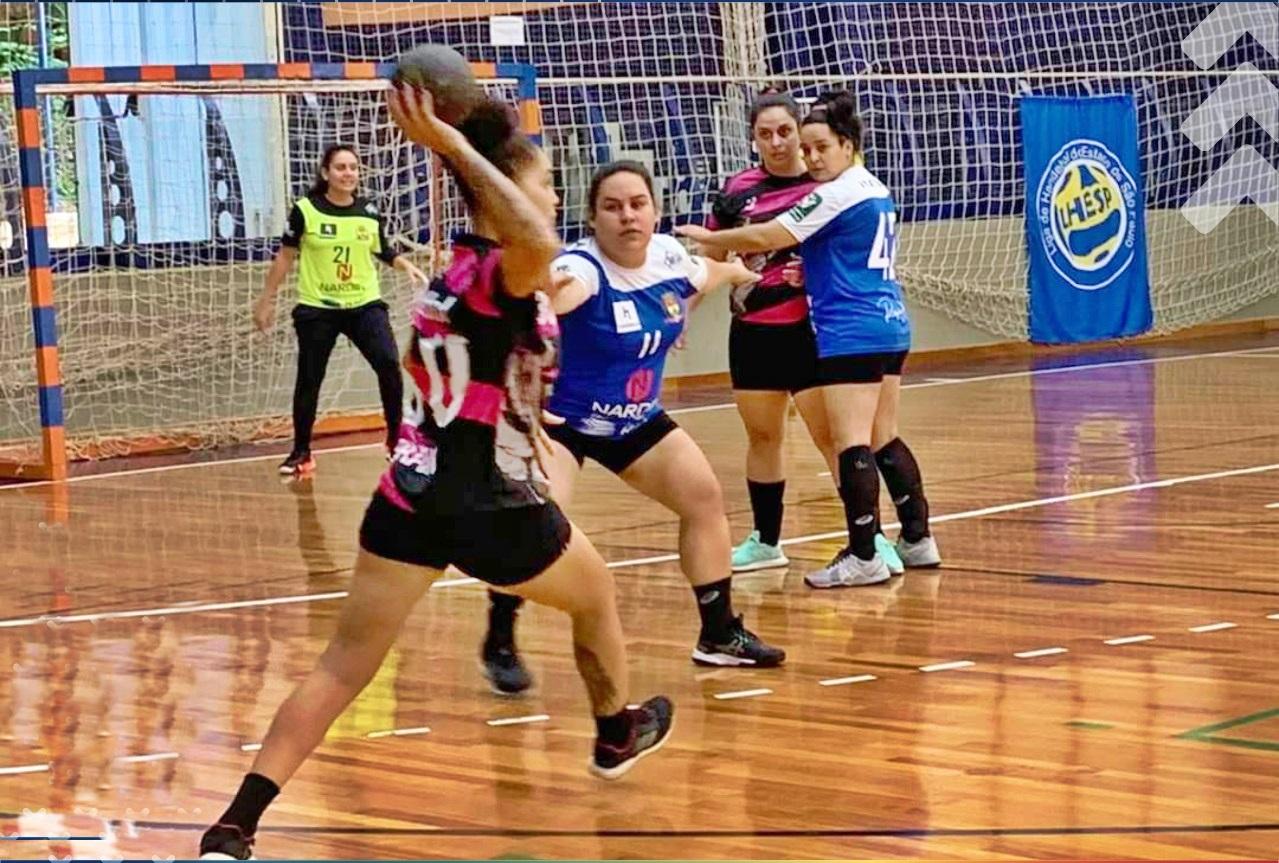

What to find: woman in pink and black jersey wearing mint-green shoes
left=706, top=89, right=900, bottom=573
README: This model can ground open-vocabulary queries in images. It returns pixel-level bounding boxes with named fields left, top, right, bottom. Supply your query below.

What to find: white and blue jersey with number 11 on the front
left=549, top=234, right=706, bottom=439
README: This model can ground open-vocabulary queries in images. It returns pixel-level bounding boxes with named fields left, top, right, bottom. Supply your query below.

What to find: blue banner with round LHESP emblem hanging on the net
left=1021, top=95, right=1154, bottom=344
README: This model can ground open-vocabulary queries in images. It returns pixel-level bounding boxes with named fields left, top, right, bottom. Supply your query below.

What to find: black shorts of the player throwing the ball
left=359, top=492, right=573, bottom=587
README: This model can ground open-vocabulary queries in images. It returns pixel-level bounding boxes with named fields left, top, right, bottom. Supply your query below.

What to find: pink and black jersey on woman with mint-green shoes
left=706, top=166, right=819, bottom=325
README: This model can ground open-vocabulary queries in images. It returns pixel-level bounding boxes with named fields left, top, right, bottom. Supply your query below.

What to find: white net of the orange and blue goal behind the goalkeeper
left=0, top=67, right=529, bottom=478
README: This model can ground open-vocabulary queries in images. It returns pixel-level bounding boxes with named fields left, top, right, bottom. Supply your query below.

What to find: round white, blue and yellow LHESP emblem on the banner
left=1035, top=138, right=1137, bottom=290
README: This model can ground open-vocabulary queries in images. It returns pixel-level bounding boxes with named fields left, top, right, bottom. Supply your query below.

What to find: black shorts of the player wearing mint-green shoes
left=728, top=318, right=817, bottom=393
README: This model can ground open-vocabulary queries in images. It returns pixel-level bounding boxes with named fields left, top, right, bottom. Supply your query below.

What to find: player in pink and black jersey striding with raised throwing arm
left=200, top=87, right=673, bottom=859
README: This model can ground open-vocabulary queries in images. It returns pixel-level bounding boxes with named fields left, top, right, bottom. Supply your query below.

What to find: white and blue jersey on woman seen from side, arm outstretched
left=776, top=165, right=911, bottom=358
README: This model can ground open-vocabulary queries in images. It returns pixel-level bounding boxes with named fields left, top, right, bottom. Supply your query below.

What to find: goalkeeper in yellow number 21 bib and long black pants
left=253, top=144, right=427, bottom=476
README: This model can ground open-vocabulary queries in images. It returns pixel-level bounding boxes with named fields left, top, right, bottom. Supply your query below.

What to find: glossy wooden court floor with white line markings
left=0, top=334, right=1279, bottom=859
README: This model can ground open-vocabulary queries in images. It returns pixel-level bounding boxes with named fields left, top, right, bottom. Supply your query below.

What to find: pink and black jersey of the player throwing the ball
left=379, top=234, right=558, bottom=513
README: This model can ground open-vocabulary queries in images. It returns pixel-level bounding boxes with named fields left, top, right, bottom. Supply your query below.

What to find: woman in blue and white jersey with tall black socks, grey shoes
left=680, top=92, right=941, bottom=587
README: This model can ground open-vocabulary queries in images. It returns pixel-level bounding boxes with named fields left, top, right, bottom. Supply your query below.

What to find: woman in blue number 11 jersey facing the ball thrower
left=483, top=161, right=785, bottom=694
